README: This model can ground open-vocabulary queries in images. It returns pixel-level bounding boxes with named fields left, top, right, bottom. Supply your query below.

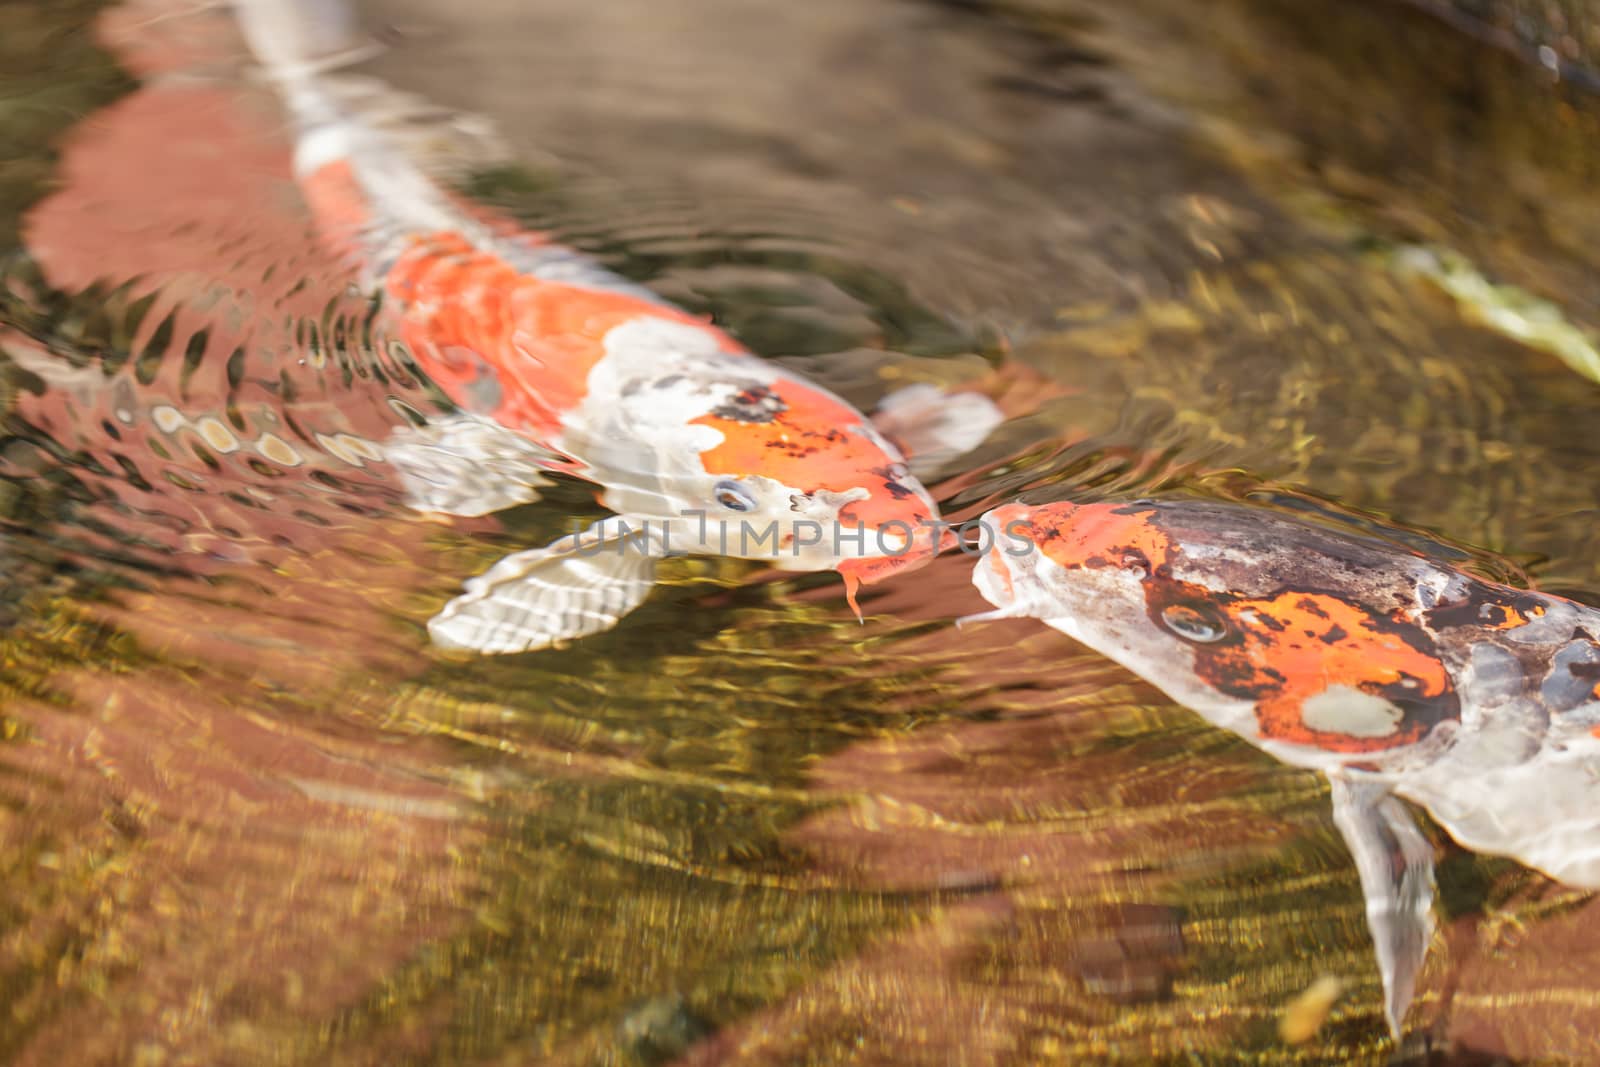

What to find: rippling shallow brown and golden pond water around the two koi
left=0, top=0, right=1600, bottom=1064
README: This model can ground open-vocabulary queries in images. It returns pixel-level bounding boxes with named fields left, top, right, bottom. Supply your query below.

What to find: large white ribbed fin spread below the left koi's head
left=427, top=517, right=667, bottom=654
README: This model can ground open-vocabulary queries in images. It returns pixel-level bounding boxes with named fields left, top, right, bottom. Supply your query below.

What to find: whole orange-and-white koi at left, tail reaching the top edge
left=235, top=0, right=1000, bottom=653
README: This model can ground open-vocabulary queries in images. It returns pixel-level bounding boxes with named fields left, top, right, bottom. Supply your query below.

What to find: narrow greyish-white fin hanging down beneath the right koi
left=1328, top=773, right=1434, bottom=1041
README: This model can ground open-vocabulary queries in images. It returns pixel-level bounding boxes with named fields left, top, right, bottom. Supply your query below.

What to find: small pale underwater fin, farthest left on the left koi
left=384, top=413, right=563, bottom=515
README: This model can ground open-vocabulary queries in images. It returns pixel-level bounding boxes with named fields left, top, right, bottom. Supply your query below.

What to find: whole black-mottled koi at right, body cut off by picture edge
left=973, top=501, right=1600, bottom=1038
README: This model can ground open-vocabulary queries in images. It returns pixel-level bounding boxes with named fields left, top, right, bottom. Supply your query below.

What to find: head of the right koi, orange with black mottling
left=973, top=501, right=1459, bottom=761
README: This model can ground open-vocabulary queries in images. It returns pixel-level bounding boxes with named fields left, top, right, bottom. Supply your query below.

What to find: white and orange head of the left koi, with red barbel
left=566, top=314, right=954, bottom=604
